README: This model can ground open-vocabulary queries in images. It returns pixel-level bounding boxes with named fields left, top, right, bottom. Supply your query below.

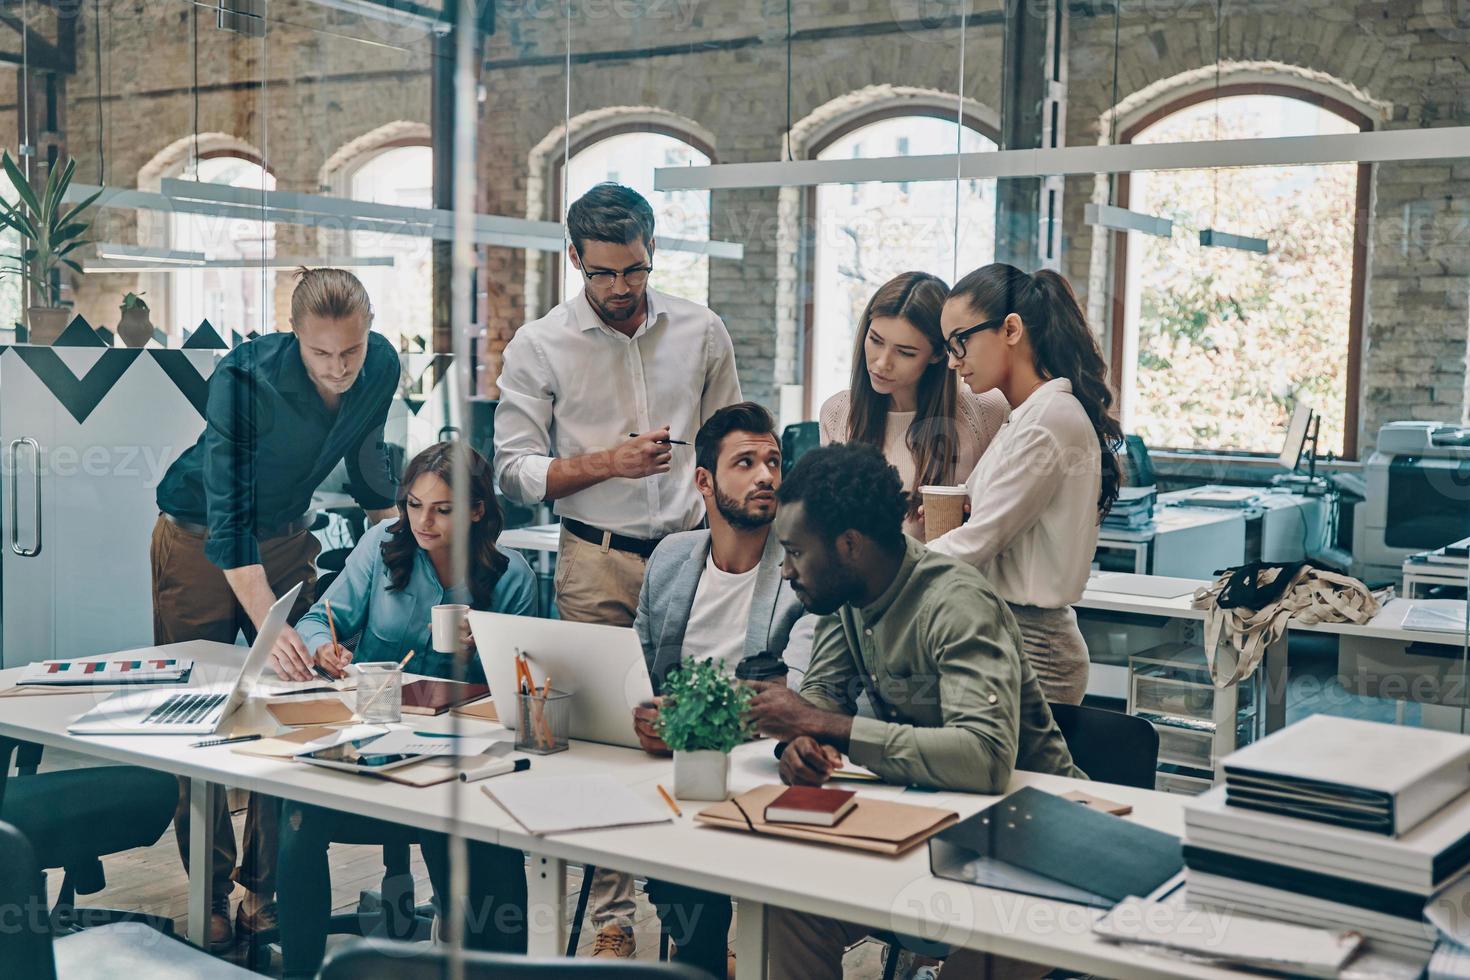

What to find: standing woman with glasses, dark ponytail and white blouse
left=929, top=263, right=1123, bottom=704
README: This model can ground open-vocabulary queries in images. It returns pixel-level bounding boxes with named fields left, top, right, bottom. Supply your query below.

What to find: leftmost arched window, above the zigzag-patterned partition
left=166, top=154, right=276, bottom=339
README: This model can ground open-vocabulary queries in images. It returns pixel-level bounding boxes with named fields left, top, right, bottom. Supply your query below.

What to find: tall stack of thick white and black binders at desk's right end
left=1183, top=716, right=1470, bottom=962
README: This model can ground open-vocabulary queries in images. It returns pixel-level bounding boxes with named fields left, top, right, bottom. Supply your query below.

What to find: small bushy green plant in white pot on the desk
left=657, top=660, right=754, bottom=799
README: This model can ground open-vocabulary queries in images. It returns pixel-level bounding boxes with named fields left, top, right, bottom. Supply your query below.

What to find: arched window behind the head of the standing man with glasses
left=553, top=123, right=710, bottom=303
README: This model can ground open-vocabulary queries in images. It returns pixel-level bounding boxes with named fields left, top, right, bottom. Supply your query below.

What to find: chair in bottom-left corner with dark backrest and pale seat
left=0, top=822, right=256, bottom=980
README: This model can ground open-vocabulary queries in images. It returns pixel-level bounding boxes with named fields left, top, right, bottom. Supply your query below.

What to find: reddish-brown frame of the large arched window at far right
left=1108, top=82, right=1373, bottom=460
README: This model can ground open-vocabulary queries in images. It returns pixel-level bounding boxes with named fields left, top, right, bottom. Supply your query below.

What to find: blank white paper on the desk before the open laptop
left=482, top=776, right=673, bottom=835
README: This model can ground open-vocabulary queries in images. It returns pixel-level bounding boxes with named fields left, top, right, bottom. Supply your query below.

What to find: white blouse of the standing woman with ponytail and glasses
left=929, top=378, right=1103, bottom=610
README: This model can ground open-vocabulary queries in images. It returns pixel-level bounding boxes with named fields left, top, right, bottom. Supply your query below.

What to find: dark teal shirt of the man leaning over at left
left=157, top=332, right=400, bottom=569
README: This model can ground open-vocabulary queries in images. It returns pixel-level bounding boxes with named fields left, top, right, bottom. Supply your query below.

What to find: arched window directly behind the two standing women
left=806, top=115, right=995, bottom=411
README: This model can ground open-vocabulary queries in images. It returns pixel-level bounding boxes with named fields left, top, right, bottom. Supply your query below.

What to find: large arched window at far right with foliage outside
left=1113, top=84, right=1372, bottom=457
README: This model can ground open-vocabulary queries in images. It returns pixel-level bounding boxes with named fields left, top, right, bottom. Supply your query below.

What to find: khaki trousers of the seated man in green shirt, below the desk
left=767, top=908, right=1051, bottom=980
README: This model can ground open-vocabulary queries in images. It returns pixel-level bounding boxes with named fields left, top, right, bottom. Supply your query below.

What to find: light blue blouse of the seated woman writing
left=295, top=520, right=537, bottom=683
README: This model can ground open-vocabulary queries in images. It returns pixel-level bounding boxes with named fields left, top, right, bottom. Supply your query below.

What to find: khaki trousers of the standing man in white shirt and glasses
left=556, top=529, right=647, bottom=929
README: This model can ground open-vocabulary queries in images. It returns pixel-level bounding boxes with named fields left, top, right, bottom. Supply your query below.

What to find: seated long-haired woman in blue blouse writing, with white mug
left=283, top=442, right=535, bottom=683
